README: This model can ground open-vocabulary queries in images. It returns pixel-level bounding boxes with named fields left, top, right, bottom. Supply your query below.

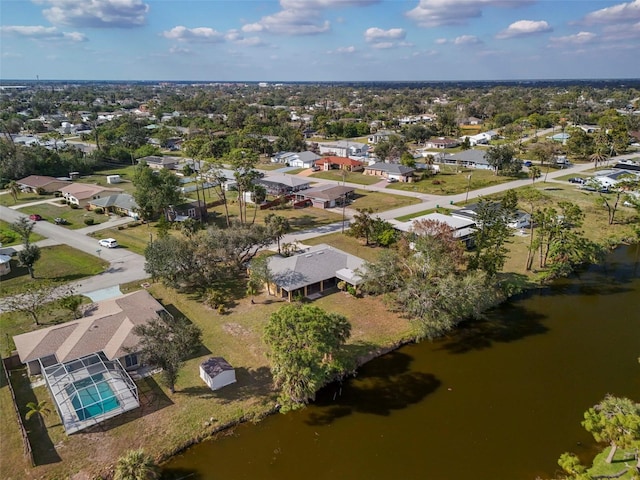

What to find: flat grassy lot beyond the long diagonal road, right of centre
left=387, top=170, right=526, bottom=195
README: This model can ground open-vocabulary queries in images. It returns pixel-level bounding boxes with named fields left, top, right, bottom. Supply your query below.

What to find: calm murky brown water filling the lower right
left=166, top=248, right=640, bottom=480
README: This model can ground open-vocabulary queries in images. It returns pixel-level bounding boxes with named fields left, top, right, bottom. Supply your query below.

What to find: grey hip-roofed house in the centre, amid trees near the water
left=269, top=244, right=365, bottom=301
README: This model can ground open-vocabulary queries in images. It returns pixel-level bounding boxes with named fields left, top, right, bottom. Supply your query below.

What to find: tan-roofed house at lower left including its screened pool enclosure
left=13, top=290, right=170, bottom=434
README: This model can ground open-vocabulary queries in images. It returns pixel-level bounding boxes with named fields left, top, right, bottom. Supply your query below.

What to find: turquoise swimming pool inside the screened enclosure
left=66, top=373, right=120, bottom=420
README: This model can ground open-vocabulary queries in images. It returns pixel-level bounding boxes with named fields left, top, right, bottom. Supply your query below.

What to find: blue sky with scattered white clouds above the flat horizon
left=0, top=0, right=640, bottom=82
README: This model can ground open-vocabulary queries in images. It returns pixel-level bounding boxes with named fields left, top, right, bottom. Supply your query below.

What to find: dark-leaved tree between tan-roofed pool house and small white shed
left=133, top=316, right=202, bottom=393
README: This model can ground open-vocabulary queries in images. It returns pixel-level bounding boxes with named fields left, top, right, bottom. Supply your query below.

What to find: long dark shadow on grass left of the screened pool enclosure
left=11, top=368, right=62, bottom=466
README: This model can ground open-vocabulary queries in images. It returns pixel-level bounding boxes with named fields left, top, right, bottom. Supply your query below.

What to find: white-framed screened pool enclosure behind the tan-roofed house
left=40, top=352, right=140, bottom=434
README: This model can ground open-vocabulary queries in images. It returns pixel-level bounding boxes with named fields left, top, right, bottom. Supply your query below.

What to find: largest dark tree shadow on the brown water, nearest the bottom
left=306, top=351, right=441, bottom=425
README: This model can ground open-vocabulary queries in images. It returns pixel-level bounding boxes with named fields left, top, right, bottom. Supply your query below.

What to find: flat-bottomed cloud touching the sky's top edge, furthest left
left=34, top=0, right=149, bottom=28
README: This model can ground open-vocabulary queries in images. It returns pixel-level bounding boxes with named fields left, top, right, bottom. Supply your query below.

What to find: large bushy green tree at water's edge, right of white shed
left=264, top=304, right=351, bottom=412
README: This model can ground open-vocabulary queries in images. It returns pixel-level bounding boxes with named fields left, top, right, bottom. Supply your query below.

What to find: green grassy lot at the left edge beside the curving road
left=0, top=245, right=108, bottom=295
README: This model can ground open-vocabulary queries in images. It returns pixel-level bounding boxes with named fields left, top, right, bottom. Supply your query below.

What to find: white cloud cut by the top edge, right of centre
left=406, top=0, right=535, bottom=27
